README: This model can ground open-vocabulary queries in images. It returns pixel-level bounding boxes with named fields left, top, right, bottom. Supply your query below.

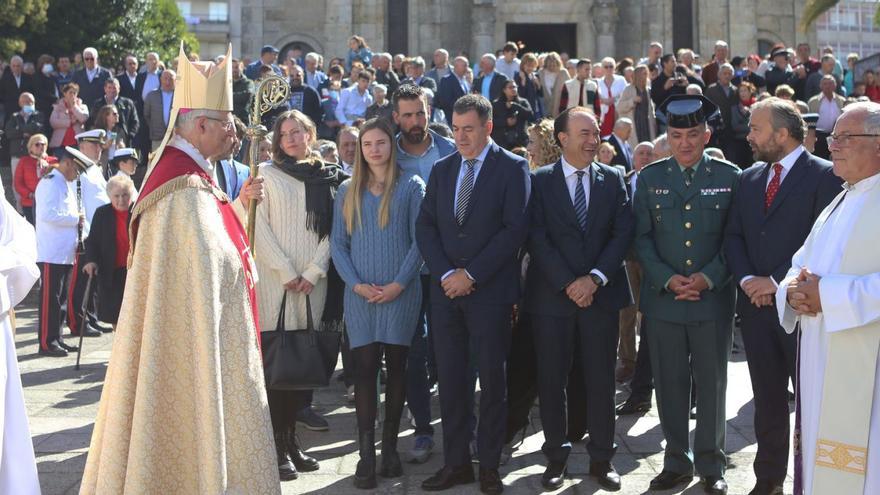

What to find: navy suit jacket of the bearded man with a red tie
left=724, top=152, right=843, bottom=315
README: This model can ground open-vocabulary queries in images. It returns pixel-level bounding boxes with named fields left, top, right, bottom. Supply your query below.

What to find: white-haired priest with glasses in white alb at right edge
left=776, top=103, right=880, bottom=495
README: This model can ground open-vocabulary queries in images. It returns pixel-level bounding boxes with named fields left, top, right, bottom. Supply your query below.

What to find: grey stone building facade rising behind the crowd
left=196, top=0, right=816, bottom=60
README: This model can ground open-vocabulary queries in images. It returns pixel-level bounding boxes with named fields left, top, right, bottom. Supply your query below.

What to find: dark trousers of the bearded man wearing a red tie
left=741, top=306, right=797, bottom=483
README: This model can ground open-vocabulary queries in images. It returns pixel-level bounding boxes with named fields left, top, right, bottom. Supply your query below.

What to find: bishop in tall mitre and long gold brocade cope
left=80, top=46, right=281, bottom=495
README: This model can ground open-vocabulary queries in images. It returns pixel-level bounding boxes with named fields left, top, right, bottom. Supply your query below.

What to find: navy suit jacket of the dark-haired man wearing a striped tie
left=416, top=142, right=530, bottom=304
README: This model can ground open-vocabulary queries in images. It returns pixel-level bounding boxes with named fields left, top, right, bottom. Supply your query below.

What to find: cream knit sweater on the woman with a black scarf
left=254, top=163, right=330, bottom=331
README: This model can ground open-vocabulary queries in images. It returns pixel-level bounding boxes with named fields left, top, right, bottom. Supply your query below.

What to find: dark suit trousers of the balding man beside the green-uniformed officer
left=535, top=306, right=620, bottom=463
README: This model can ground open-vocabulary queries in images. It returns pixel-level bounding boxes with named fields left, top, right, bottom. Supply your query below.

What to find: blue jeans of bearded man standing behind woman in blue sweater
left=406, top=274, right=434, bottom=436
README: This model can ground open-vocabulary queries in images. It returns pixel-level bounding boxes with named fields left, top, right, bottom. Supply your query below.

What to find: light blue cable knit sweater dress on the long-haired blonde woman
left=330, top=175, right=425, bottom=348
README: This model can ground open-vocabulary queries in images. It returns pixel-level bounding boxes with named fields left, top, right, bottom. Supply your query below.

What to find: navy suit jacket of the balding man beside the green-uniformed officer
left=525, top=160, right=635, bottom=316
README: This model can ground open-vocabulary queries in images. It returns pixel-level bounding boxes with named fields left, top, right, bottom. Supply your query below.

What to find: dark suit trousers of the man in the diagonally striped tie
left=431, top=300, right=513, bottom=469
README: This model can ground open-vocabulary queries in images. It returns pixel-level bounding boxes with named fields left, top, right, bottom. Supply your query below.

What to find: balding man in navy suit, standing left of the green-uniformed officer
left=525, top=107, right=635, bottom=490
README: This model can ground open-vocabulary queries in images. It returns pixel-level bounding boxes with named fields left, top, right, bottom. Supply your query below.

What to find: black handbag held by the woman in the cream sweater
left=260, top=291, right=340, bottom=390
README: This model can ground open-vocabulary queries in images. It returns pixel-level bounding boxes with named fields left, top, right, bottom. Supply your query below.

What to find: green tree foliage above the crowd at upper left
left=0, top=0, right=198, bottom=67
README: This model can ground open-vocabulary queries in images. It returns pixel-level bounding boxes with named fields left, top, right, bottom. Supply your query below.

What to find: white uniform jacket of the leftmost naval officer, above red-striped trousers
left=34, top=170, right=78, bottom=265
